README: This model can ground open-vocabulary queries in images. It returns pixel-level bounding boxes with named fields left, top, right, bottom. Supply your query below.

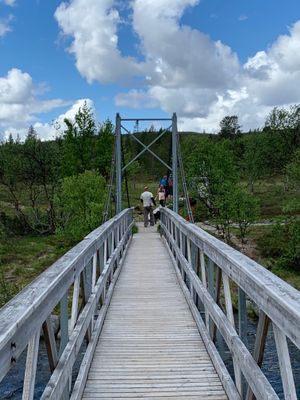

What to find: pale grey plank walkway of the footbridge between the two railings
left=83, top=226, right=227, bottom=400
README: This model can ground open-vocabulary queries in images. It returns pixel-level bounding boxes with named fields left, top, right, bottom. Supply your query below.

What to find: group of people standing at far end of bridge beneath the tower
left=140, top=175, right=173, bottom=227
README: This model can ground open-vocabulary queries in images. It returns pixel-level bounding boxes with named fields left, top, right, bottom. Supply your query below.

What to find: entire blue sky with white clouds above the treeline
left=0, top=0, right=300, bottom=140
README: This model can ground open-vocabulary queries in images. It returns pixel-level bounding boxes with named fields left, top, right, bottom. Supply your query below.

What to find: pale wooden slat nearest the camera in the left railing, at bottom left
left=22, top=329, right=40, bottom=400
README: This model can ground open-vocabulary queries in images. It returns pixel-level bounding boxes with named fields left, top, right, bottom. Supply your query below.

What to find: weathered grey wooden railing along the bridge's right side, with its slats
left=161, top=208, right=300, bottom=400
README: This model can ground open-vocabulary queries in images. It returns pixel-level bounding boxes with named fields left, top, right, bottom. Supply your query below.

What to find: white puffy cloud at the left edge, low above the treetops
left=0, top=68, right=69, bottom=138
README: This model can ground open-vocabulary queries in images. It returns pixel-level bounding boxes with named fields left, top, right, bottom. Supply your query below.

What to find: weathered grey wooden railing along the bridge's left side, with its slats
left=0, top=209, right=133, bottom=400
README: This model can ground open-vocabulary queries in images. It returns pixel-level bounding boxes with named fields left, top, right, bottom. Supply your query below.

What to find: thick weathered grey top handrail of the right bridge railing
left=161, top=208, right=300, bottom=348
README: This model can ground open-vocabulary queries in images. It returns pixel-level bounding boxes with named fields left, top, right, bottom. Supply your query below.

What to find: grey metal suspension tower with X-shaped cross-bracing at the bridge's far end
left=115, top=113, right=178, bottom=213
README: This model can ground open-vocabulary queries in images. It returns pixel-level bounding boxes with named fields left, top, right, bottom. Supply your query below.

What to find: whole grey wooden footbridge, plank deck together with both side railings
left=0, top=208, right=300, bottom=400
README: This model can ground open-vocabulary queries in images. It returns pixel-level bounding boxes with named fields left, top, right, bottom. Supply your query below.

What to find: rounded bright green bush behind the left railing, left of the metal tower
left=55, top=171, right=106, bottom=241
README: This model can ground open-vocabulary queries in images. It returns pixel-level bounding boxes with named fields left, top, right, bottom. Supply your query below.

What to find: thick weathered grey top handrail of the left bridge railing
left=0, top=210, right=130, bottom=380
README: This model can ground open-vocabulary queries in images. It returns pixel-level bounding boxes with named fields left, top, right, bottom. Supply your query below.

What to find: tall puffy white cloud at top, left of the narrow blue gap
left=55, top=0, right=139, bottom=82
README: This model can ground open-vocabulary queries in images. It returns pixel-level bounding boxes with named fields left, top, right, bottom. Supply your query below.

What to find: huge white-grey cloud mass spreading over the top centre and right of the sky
left=55, top=0, right=300, bottom=131
